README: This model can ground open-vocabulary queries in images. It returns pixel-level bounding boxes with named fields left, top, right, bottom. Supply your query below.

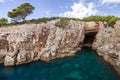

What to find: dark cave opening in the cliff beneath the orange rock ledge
left=83, top=32, right=97, bottom=47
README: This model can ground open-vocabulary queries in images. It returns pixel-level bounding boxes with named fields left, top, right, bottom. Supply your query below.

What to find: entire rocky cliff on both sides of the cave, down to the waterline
left=0, top=19, right=120, bottom=73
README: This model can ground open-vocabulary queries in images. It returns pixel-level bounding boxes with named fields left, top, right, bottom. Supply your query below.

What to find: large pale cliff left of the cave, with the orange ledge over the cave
left=0, top=20, right=103, bottom=66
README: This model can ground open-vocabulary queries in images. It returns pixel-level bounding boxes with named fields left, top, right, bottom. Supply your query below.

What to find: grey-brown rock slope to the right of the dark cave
left=92, top=21, right=120, bottom=72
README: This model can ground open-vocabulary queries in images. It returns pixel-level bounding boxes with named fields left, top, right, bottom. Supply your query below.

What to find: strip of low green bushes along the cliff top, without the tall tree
left=0, top=16, right=120, bottom=27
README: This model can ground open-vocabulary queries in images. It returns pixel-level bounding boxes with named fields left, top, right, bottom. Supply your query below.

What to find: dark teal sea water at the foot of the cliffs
left=0, top=48, right=120, bottom=80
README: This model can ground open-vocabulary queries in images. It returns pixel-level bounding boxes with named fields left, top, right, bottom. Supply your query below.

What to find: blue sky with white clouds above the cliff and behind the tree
left=0, top=0, right=120, bottom=19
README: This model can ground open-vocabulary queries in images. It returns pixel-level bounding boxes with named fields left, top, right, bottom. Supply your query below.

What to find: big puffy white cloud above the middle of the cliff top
left=60, top=2, right=98, bottom=19
